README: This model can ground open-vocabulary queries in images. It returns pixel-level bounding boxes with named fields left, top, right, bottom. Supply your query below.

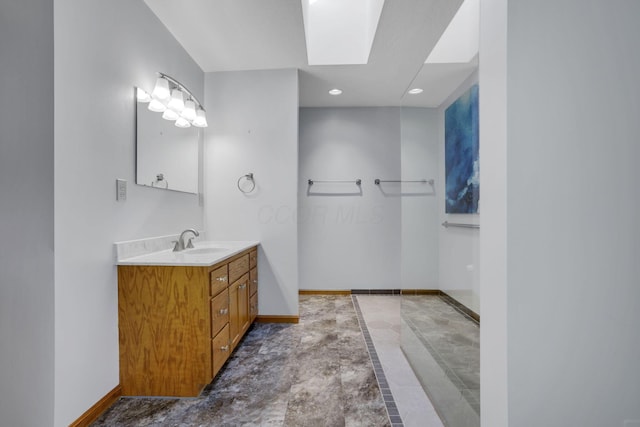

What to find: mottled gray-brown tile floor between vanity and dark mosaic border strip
left=93, top=296, right=391, bottom=427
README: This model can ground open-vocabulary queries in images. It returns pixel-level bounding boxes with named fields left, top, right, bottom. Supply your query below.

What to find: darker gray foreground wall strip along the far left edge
left=0, top=0, right=54, bottom=427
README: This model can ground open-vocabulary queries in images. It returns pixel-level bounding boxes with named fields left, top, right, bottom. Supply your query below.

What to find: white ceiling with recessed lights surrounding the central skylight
left=144, top=0, right=477, bottom=107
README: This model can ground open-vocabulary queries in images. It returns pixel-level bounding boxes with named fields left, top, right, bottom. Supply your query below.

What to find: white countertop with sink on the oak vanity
left=117, top=241, right=260, bottom=267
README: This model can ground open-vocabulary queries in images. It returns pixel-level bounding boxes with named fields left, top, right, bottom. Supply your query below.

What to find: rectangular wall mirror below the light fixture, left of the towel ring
left=136, top=89, right=200, bottom=193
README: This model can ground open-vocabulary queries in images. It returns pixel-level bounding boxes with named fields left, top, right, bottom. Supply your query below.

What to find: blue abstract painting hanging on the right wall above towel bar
left=444, top=85, right=480, bottom=214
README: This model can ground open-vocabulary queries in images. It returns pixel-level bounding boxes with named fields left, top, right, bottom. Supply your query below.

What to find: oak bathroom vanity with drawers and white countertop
left=118, top=242, right=258, bottom=397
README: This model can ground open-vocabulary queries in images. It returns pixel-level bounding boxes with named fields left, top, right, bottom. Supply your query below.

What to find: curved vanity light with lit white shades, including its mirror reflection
left=144, top=73, right=208, bottom=128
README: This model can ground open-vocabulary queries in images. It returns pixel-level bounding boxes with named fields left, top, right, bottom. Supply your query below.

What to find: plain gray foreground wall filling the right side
left=480, top=0, right=640, bottom=427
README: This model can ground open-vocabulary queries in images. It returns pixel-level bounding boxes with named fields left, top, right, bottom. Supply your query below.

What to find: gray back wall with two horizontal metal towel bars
left=298, top=107, right=441, bottom=290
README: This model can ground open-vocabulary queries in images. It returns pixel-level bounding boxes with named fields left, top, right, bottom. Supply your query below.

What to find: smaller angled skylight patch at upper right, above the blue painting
left=422, top=0, right=480, bottom=64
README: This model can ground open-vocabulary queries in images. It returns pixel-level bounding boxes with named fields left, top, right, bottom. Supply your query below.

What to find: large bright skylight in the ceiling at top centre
left=301, top=0, right=384, bottom=65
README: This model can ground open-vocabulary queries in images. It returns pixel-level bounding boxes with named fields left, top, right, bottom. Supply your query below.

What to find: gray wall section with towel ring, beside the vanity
left=204, top=69, right=298, bottom=315
